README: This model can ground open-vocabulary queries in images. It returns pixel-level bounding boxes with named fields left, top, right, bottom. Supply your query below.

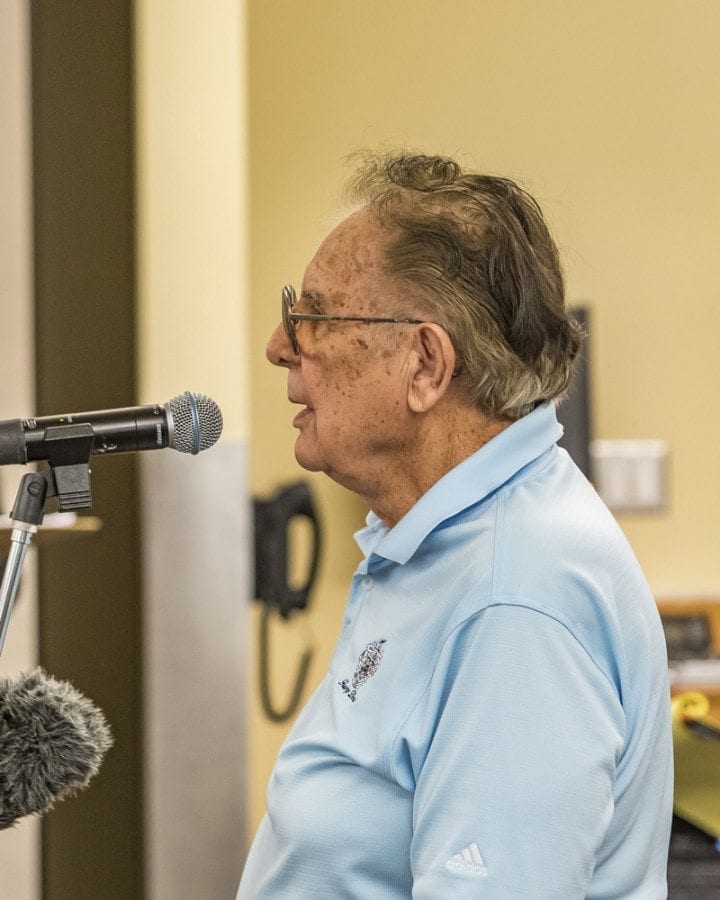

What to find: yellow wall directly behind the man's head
left=248, top=0, right=720, bottom=826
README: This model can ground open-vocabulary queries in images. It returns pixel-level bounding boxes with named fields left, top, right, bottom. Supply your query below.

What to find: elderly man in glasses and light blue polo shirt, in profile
left=238, top=156, right=672, bottom=900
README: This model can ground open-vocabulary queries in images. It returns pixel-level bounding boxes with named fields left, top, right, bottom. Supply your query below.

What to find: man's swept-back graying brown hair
left=346, top=154, right=583, bottom=419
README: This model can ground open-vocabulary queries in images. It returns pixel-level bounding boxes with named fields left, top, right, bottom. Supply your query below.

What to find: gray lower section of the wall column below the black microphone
left=141, top=441, right=252, bottom=900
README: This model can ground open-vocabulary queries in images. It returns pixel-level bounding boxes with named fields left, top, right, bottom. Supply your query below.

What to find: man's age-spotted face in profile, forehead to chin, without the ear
left=267, top=210, right=413, bottom=493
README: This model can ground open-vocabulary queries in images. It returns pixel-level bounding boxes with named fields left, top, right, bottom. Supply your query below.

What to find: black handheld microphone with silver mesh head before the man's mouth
left=0, top=391, right=223, bottom=466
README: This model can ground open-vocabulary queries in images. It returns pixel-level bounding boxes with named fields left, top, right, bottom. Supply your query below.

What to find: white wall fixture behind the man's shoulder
left=590, top=440, right=669, bottom=512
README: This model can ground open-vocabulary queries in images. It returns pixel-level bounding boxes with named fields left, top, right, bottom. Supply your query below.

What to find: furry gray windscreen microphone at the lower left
left=0, top=668, right=112, bottom=828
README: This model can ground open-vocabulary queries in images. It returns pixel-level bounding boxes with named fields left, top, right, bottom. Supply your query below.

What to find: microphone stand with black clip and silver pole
left=0, top=424, right=95, bottom=655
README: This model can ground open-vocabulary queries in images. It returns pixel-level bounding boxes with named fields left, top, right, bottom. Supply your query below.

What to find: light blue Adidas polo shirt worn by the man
left=238, top=404, right=672, bottom=900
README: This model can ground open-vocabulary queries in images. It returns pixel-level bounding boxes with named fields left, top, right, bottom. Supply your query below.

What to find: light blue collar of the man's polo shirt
left=355, top=403, right=563, bottom=564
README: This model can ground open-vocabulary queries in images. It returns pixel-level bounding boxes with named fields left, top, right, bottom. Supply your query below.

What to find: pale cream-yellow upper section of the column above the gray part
left=135, top=0, right=249, bottom=439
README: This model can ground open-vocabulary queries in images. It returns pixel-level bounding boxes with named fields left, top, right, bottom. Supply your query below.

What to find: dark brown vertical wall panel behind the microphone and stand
left=31, top=0, right=143, bottom=900
